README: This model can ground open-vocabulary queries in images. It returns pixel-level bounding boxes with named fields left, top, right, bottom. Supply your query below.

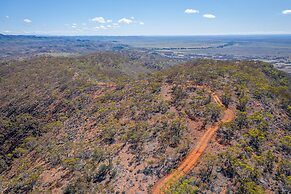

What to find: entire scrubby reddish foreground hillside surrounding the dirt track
left=0, top=52, right=291, bottom=193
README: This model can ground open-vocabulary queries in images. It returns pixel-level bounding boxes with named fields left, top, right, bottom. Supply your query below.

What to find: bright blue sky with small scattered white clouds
left=0, top=0, right=291, bottom=35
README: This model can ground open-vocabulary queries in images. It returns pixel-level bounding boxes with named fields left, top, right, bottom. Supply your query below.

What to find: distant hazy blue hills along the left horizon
left=0, top=35, right=127, bottom=60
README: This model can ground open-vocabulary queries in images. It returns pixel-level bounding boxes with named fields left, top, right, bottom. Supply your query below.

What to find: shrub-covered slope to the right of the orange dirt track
left=156, top=61, right=291, bottom=193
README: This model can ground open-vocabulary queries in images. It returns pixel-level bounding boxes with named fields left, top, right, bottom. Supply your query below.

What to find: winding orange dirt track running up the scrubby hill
left=152, top=93, right=235, bottom=194
